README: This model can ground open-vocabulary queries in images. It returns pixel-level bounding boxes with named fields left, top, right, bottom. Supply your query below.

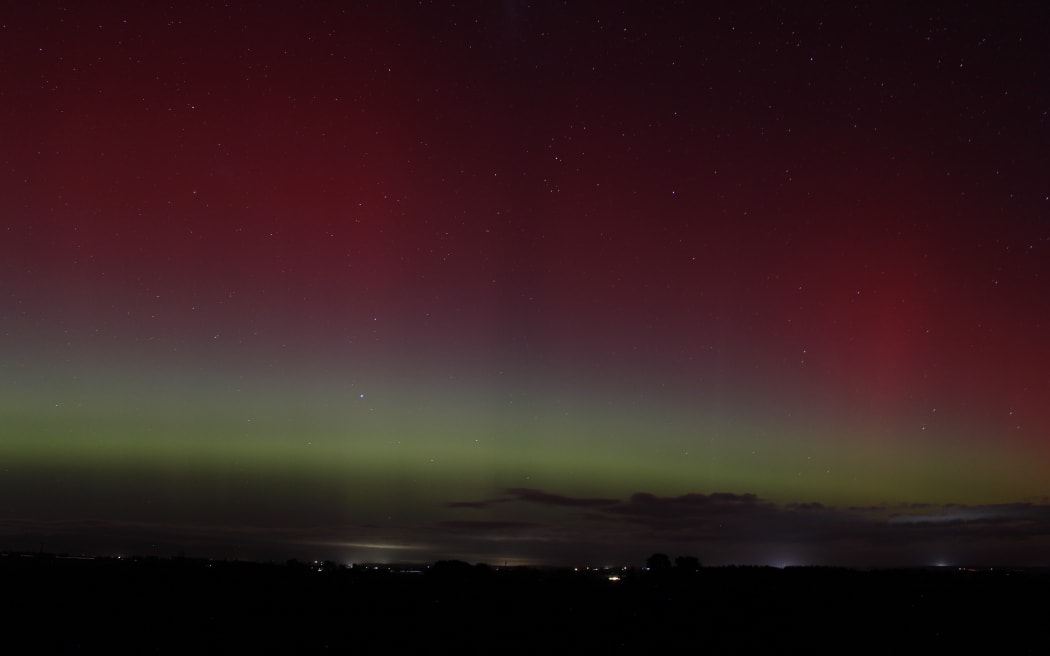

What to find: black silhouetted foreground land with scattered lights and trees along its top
left=0, top=554, right=1050, bottom=654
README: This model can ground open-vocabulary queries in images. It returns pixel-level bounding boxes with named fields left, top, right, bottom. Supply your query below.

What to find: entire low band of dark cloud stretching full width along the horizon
left=16, top=488, right=1050, bottom=566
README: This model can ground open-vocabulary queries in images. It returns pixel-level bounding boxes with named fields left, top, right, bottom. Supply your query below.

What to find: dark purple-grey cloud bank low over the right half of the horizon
left=447, top=488, right=1050, bottom=566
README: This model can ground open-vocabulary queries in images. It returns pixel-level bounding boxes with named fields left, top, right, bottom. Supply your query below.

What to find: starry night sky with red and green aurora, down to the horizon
left=0, top=0, right=1050, bottom=566
